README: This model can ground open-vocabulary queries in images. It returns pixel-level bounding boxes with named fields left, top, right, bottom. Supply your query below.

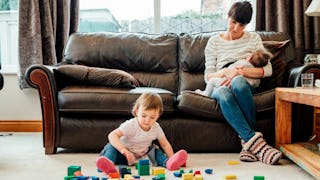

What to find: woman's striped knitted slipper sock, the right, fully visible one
left=243, top=132, right=282, bottom=165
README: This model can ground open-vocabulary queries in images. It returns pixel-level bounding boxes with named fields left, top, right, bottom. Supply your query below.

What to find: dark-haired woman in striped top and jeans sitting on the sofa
left=204, top=1, right=282, bottom=164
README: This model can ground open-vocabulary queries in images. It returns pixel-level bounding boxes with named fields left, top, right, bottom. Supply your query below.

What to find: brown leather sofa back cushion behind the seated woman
left=179, top=32, right=295, bottom=92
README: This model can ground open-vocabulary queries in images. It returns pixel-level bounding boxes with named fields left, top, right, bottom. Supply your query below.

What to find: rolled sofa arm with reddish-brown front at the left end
left=26, top=65, right=59, bottom=154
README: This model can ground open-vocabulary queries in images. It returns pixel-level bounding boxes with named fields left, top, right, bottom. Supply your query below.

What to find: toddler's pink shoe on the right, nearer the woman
left=166, top=150, right=188, bottom=171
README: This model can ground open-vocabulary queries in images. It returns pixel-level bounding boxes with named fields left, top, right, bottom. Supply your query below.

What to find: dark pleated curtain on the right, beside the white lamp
left=256, top=0, right=320, bottom=63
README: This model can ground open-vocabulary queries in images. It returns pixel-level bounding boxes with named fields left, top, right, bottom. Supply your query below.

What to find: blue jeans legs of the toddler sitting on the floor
left=100, top=143, right=168, bottom=167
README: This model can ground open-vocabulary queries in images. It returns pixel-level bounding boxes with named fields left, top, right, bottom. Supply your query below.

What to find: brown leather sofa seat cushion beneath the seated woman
left=178, top=89, right=275, bottom=119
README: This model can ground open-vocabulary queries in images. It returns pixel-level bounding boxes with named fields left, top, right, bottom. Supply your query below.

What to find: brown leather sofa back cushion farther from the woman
left=64, top=32, right=178, bottom=93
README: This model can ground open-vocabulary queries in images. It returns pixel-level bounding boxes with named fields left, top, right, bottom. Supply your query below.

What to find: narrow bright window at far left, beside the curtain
left=0, top=0, right=18, bottom=73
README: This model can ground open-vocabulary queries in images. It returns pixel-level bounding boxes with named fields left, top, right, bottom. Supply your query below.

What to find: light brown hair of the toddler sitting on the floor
left=132, top=92, right=163, bottom=117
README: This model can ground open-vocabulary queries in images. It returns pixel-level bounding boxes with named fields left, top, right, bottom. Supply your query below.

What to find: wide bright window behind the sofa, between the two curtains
left=79, top=0, right=255, bottom=34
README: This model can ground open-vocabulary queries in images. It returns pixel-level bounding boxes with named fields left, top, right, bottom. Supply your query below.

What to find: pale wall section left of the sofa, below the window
left=0, top=73, right=42, bottom=121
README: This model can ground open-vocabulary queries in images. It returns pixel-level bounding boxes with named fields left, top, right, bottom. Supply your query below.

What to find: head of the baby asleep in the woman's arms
left=247, top=49, right=272, bottom=67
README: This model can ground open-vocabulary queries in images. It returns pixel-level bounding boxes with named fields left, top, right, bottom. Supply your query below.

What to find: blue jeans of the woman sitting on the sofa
left=211, top=76, right=256, bottom=142
